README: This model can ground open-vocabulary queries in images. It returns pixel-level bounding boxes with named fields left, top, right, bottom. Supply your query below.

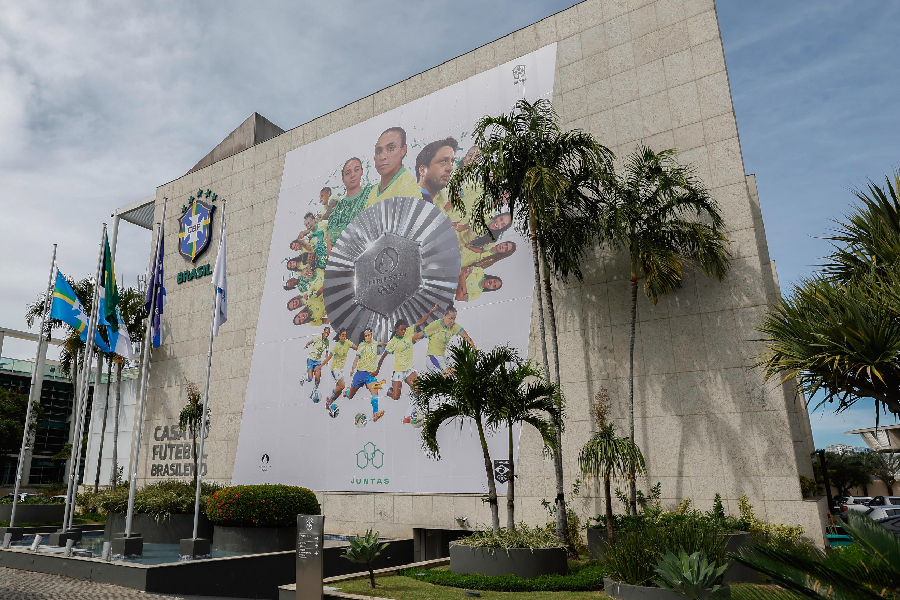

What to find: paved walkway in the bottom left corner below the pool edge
left=0, top=567, right=246, bottom=600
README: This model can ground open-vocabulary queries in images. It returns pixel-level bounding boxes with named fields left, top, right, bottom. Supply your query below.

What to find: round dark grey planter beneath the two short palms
left=450, top=544, right=569, bottom=578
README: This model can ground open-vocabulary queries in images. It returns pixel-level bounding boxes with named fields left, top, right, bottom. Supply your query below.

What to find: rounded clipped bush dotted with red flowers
left=206, top=485, right=322, bottom=527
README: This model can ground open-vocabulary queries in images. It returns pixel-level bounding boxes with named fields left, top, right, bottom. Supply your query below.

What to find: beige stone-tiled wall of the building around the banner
left=139, top=0, right=822, bottom=542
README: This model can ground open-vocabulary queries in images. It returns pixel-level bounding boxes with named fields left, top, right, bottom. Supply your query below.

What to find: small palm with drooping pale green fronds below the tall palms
left=578, top=390, right=644, bottom=544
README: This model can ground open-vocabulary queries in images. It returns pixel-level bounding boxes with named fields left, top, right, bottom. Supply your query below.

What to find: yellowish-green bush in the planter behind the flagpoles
left=76, top=481, right=222, bottom=519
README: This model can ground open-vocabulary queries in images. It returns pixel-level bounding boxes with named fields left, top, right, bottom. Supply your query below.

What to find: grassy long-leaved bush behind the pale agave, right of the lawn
left=606, top=521, right=728, bottom=586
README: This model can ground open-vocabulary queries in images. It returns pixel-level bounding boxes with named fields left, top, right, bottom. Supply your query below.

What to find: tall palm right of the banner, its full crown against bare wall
left=597, top=146, right=729, bottom=514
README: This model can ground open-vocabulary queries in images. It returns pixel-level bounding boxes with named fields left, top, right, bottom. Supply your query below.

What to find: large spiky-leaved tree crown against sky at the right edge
left=758, top=172, right=900, bottom=415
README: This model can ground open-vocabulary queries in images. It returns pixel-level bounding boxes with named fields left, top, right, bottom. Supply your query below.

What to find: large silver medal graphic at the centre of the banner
left=322, top=198, right=460, bottom=341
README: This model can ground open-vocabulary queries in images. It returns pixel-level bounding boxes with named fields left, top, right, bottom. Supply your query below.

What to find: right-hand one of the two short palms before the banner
left=486, top=347, right=563, bottom=531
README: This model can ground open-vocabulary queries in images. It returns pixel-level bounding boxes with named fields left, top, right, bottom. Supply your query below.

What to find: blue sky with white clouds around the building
left=0, top=0, right=900, bottom=446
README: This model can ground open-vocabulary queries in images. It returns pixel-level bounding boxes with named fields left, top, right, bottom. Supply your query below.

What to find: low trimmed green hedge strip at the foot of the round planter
left=399, top=562, right=606, bottom=592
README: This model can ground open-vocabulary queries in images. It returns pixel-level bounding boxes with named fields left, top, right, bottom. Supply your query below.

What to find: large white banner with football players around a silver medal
left=233, top=44, right=556, bottom=493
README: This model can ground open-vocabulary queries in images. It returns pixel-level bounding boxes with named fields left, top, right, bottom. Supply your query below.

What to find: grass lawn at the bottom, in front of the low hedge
left=333, top=575, right=609, bottom=600
